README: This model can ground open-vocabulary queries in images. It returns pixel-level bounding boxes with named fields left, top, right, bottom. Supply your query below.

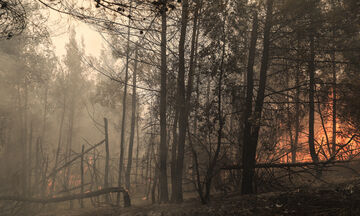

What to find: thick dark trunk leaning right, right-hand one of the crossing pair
left=242, top=0, right=273, bottom=194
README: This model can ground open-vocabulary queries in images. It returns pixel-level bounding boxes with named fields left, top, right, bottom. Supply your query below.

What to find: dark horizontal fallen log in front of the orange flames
left=221, top=160, right=353, bottom=170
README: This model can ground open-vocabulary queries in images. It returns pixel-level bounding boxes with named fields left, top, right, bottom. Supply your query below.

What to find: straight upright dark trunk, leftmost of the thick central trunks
left=159, top=0, right=169, bottom=202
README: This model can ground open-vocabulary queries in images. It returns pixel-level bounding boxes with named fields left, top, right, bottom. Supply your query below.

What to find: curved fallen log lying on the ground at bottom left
left=0, top=187, right=128, bottom=204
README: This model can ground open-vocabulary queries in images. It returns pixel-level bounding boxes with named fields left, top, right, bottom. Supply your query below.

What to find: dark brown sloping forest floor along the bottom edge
left=36, top=178, right=360, bottom=216
